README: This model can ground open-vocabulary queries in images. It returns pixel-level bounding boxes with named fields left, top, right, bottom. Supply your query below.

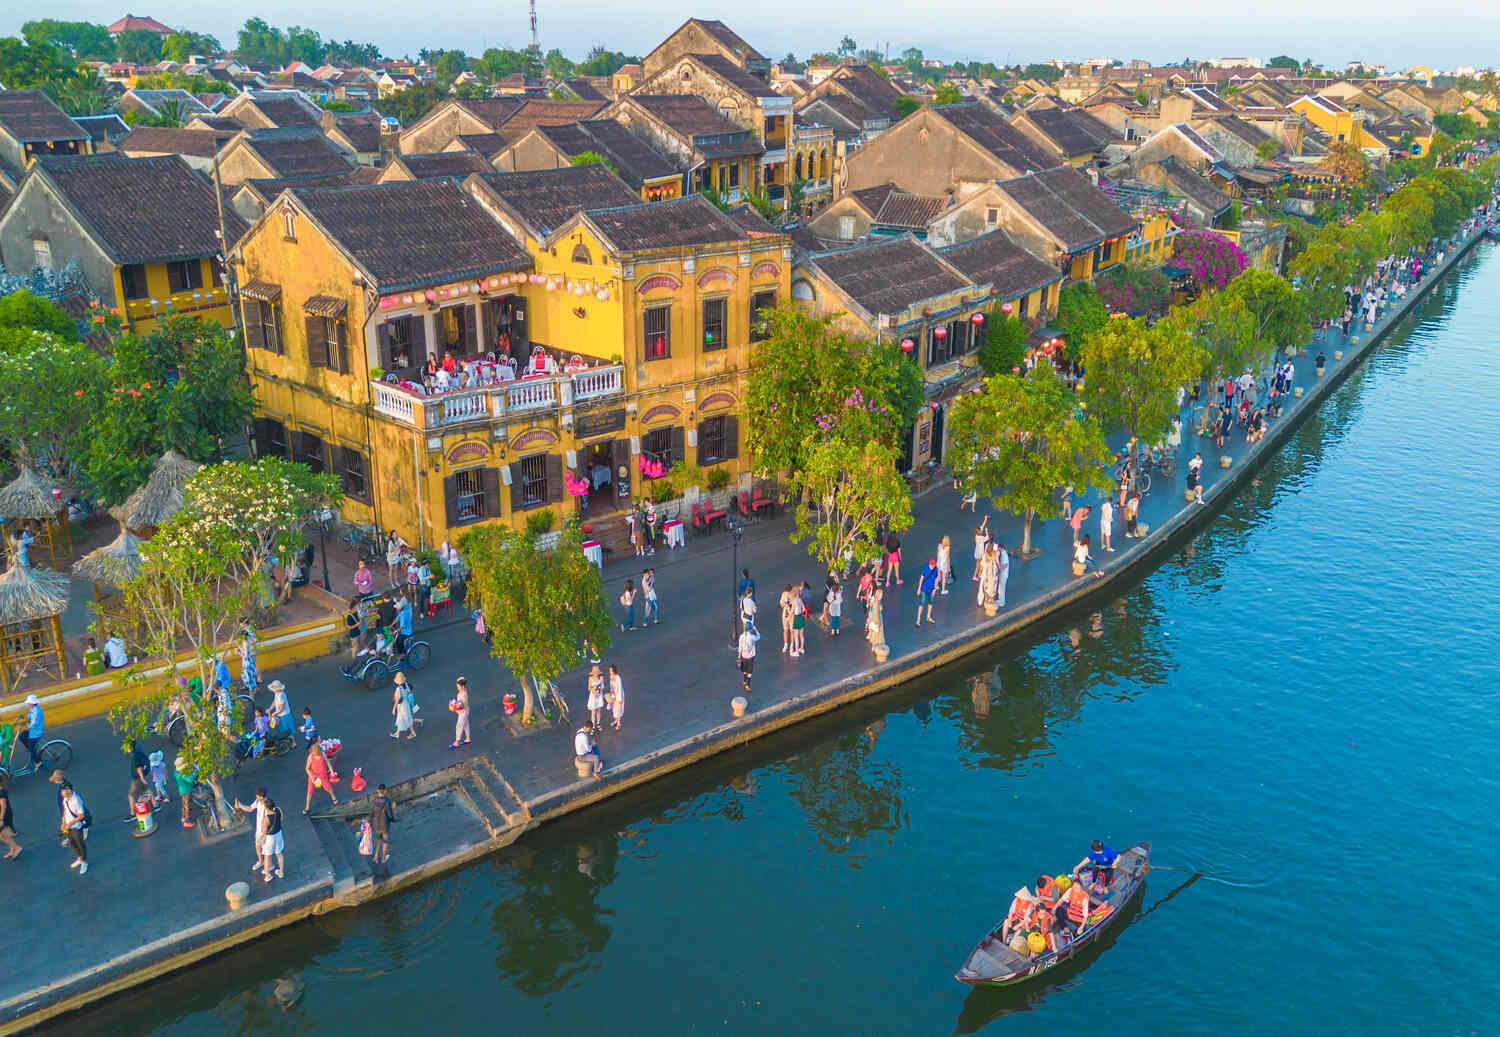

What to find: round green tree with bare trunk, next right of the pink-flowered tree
left=948, top=371, right=1112, bottom=557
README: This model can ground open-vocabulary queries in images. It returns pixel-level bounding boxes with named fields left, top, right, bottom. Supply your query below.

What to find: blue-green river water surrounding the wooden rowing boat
left=87, top=246, right=1500, bottom=1034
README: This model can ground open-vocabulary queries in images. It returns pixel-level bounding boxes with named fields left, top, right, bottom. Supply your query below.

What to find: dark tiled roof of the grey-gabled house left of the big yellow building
left=35, top=155, right=245, bottom=264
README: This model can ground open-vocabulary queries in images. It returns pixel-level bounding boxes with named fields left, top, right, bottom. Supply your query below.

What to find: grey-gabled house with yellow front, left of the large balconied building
left=0, top=155, right=245, bottom=335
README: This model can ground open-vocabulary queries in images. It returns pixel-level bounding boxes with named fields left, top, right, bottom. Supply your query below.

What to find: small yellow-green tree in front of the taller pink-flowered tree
left=792, top=414, right=912, bottom=569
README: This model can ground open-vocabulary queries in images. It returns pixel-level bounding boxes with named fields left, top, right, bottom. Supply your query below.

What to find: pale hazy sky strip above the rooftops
left=0, top=0, right=1500, bottom=68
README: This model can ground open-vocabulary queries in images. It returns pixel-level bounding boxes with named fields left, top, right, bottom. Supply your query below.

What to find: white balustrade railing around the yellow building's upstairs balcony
left=371, top=363, right=626, bottom=429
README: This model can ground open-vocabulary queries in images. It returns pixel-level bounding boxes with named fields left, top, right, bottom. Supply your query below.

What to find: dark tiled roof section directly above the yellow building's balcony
left=293, top=180, right=531, bottom=291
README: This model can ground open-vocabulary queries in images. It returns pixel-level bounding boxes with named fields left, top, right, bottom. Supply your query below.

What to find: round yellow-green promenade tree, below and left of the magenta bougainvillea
left=1080, top=317, right=1203, bottom=452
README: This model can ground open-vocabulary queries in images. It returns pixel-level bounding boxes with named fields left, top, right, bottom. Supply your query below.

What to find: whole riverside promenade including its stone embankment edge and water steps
left=0, top=225, right=1475, bottom=1032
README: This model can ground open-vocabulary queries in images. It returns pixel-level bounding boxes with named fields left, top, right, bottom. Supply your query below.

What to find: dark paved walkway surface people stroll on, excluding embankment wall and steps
left=0, top=220, right=1476, bottom=1029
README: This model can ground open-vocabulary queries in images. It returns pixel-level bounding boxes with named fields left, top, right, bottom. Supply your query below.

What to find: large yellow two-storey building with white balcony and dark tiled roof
left=236, top=165, right=789, bottom=548
